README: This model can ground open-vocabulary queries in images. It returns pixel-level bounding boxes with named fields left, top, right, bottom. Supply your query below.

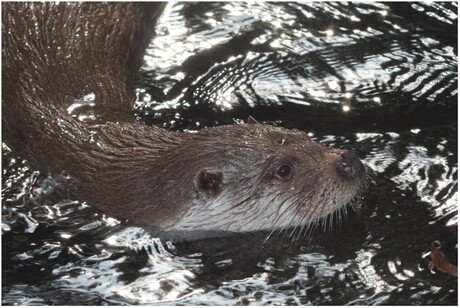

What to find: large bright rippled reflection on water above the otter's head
left=138, top=3, right=458, bottom=120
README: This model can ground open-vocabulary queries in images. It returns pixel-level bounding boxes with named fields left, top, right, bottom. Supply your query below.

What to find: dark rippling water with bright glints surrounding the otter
left=2, top=2, right=458, bottom=305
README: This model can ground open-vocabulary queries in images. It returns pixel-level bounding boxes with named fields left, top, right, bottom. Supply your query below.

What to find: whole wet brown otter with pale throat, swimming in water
left=2, top=3, right=366, bottom=232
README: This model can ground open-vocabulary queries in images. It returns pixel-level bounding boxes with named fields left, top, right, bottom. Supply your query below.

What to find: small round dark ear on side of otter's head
left=193, top=168, right=224, bottom=198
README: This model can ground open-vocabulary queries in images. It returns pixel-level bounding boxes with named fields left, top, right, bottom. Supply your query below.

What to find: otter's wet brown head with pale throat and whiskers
left=163, top=124, right=366, bottom=232
